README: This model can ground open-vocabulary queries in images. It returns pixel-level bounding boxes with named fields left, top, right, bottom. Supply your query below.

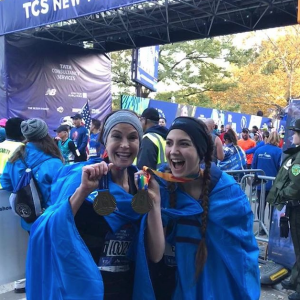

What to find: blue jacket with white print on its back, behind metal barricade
left=251, top=144, right=282, bottom=191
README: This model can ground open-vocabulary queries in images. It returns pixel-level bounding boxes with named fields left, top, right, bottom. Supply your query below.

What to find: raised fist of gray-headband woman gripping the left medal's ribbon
left=79, top=161, right=113, bottom=195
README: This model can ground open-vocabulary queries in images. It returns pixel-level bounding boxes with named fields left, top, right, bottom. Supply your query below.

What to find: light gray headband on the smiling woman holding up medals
left=103, top=110, right=143, bottom=145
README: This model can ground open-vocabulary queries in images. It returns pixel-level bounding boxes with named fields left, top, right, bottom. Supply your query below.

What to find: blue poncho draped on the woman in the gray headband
left=26, top=160, right=140, bottom=300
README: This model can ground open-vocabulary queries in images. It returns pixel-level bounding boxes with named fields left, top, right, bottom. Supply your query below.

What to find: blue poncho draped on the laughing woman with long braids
left=133, top=167, right=260, bottom=300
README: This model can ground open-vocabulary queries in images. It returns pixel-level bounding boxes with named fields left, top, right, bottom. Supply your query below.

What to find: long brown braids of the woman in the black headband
left=167, top=119, right=214, bottom=278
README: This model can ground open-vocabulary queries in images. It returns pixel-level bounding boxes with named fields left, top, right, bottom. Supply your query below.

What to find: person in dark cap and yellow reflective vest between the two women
left=136, top=107, right=168, bottom=170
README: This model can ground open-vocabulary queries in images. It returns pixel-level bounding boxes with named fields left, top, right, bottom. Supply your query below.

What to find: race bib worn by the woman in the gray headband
left=98, top=225, right=134, bottom=272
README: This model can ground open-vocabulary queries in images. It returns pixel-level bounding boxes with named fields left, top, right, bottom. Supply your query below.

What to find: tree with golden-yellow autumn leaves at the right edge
left=209, top=26, right=300, bottom=115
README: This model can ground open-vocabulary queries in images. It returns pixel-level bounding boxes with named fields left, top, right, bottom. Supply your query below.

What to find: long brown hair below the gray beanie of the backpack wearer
left=9, top=134, right=64, bottom=163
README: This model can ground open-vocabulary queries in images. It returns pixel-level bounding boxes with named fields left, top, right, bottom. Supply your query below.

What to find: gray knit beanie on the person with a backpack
left=21, top=118, right=48, bottom=141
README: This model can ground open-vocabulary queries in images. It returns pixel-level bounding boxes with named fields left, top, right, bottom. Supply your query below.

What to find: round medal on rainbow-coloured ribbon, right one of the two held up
left=131, top=175, right=153, bottom=214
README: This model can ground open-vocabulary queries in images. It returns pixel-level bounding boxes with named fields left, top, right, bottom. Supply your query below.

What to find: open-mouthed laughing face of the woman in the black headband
left=166, top=129, right=200, bottom=177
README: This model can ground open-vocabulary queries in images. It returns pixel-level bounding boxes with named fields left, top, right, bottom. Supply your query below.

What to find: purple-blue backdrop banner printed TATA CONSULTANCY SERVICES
left=0, top=37, right=111, bottom=134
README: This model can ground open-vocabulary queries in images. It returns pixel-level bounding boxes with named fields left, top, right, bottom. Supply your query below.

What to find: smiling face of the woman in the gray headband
left=105, top=123, right=139, bottom=168
